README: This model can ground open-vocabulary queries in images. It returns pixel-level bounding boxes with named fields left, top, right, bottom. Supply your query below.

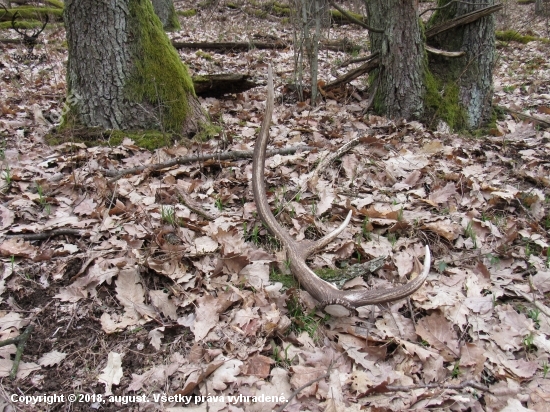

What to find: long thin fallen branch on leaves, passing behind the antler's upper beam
left=103, top=145, right=315, bottom=183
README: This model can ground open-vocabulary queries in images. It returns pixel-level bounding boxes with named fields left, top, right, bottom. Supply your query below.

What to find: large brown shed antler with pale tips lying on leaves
left=252, top=66, right=431, bottom=308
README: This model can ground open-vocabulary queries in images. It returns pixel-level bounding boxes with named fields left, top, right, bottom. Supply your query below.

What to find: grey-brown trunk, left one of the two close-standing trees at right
left=366, top=0, right=425, bottom=119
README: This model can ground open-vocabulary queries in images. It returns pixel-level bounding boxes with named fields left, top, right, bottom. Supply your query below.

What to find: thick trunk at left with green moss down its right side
left=64, top=0, right=207, bottom=134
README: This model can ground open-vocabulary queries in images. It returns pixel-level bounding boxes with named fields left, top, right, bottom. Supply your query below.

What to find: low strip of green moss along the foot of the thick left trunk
left=45, top=127, right=179, bottom=150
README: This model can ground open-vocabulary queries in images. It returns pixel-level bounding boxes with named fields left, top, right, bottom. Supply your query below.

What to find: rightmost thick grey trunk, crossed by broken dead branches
left=429, top=0, right=496, bottom=129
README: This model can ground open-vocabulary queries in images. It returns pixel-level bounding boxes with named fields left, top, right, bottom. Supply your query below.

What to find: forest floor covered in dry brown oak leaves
left=0, top=2, right=550, bottom=412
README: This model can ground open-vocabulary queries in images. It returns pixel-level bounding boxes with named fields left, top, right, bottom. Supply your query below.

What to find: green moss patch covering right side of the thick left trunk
left=125, top=0, right=195, bottom=132
